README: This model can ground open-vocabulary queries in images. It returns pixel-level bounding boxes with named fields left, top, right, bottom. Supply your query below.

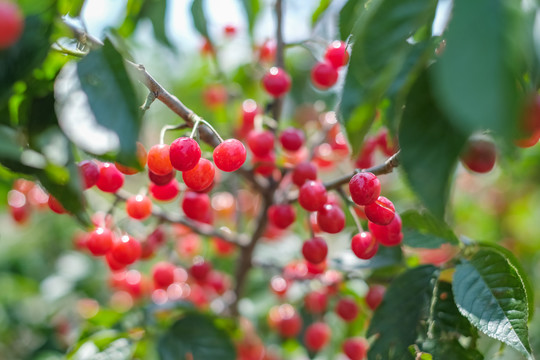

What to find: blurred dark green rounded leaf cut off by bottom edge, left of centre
left=158, top=313, right=236, bottom=360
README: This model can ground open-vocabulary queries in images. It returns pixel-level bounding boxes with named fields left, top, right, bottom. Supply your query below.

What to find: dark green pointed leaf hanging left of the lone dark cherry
left=398, top=72, right=467, bottom=219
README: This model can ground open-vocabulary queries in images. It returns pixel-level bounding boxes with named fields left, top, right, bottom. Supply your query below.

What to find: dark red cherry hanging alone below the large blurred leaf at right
left=461, top=137, right=497, bottom=174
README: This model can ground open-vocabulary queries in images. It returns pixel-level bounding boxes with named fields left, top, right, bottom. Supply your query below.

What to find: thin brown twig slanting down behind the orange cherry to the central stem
left=114, top=190, right=248, bottom=247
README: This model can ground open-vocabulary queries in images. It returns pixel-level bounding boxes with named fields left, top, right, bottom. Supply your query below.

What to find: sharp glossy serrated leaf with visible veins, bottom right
left=452, top=249, right=533, bottom=359
